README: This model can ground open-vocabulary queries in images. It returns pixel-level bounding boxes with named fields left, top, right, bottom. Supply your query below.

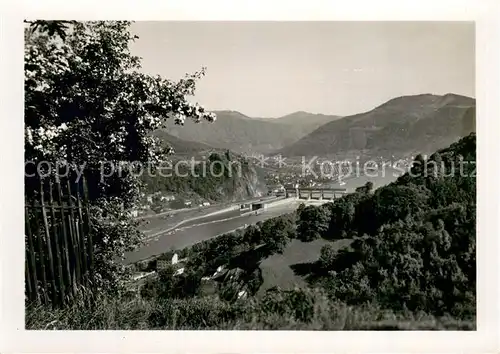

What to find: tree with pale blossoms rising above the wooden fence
left=24, top=21, right=215, bottom=289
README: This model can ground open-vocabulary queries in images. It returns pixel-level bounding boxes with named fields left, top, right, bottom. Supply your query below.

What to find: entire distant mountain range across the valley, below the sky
left=163, top=93, right=475, bottom=156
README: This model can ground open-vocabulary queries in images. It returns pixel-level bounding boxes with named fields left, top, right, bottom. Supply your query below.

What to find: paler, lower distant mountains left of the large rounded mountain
left=167, top=111, right=338, bottom=153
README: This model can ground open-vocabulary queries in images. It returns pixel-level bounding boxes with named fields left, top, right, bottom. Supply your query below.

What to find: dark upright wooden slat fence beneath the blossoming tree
left=25, top=178, right=94, bottom=304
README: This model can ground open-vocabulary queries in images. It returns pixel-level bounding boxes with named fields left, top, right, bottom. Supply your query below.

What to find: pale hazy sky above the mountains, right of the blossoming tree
left=128, top=22, right=475, bottom=117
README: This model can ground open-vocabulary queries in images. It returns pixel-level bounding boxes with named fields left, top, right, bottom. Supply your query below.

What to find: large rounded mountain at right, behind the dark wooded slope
left=276, top=94, right=476, bottom=156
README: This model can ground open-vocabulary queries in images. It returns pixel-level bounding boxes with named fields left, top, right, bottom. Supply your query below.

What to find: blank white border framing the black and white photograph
left=0, top=0, right=500, bottom=353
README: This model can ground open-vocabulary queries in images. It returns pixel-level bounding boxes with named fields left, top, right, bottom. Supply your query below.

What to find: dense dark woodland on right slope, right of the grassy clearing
left=312, top=134, right=476, bottom=318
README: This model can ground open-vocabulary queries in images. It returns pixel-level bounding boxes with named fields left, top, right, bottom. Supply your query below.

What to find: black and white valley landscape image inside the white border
left=2, top=0, right=498, bottom=351
